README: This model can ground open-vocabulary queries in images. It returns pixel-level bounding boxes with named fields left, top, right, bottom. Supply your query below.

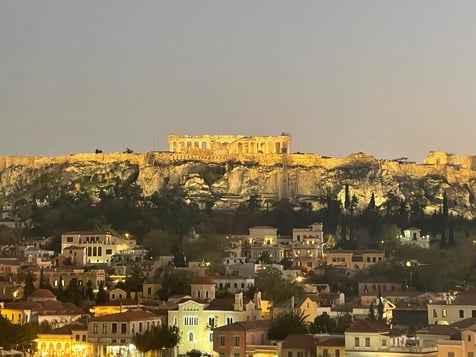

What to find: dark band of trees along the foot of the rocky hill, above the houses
left=12, top=184, right=475, bottom=253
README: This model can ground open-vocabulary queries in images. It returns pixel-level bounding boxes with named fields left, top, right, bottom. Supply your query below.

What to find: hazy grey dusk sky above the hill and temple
left=0, top=0, right=476, bottom=162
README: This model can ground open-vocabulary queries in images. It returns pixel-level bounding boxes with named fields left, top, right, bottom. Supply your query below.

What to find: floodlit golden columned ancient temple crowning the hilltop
left=168, top=133, right=291, bottom=154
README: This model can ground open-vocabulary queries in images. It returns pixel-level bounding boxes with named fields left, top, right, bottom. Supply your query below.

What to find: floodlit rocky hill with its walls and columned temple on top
left=0, top=133, right=476, bottom=218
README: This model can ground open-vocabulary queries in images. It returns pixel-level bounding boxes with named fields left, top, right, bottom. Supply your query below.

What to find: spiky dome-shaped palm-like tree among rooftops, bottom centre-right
left=269, top=309, right=308, bottom=340
